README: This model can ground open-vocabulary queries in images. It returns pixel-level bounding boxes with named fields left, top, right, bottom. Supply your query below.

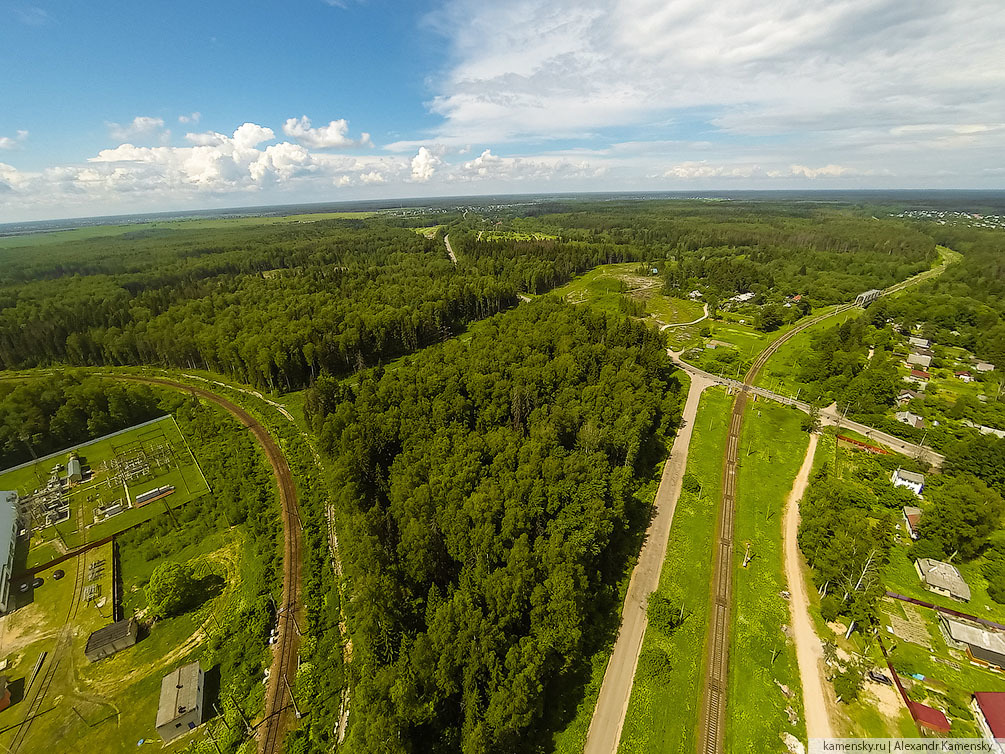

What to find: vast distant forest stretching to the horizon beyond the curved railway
left=0, top=202, right=935, bottom=390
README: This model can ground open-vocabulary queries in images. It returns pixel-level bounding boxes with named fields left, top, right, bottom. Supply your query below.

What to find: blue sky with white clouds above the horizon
left=0, top=0, right=1005, bottom=222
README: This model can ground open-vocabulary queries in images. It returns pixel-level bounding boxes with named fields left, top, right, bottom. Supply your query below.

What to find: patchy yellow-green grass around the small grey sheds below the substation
left=0, top=527, right=253, bottom=754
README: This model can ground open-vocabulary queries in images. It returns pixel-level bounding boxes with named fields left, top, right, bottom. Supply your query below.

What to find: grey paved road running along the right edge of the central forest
left=583, top=376, right=714, bottom=754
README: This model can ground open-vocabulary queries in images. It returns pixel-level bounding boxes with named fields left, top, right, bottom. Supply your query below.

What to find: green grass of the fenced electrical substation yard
left=0, top=416, right=209, bottom=568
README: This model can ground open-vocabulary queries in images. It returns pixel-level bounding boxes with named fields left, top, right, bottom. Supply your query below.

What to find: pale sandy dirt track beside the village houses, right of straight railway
left=782, top=433, right=834, bottom=738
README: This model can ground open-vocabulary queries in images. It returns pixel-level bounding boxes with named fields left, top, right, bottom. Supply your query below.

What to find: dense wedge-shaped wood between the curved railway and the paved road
left=308, top=300, right=681, bottom=754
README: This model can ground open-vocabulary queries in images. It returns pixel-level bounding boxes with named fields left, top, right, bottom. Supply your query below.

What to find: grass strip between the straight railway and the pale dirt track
left=726, top=401, right=809, bottom=752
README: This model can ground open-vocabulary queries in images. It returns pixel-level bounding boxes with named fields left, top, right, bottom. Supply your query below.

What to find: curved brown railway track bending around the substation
left=102, top=374, right=303, bottom=754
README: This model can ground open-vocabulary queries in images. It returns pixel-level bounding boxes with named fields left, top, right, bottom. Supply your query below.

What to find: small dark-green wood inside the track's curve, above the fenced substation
left=0, top=372, right=164, bottom=468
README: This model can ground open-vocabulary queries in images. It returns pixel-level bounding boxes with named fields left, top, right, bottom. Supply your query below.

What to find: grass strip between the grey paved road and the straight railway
left=618, top=388, right=733, bottom=754
